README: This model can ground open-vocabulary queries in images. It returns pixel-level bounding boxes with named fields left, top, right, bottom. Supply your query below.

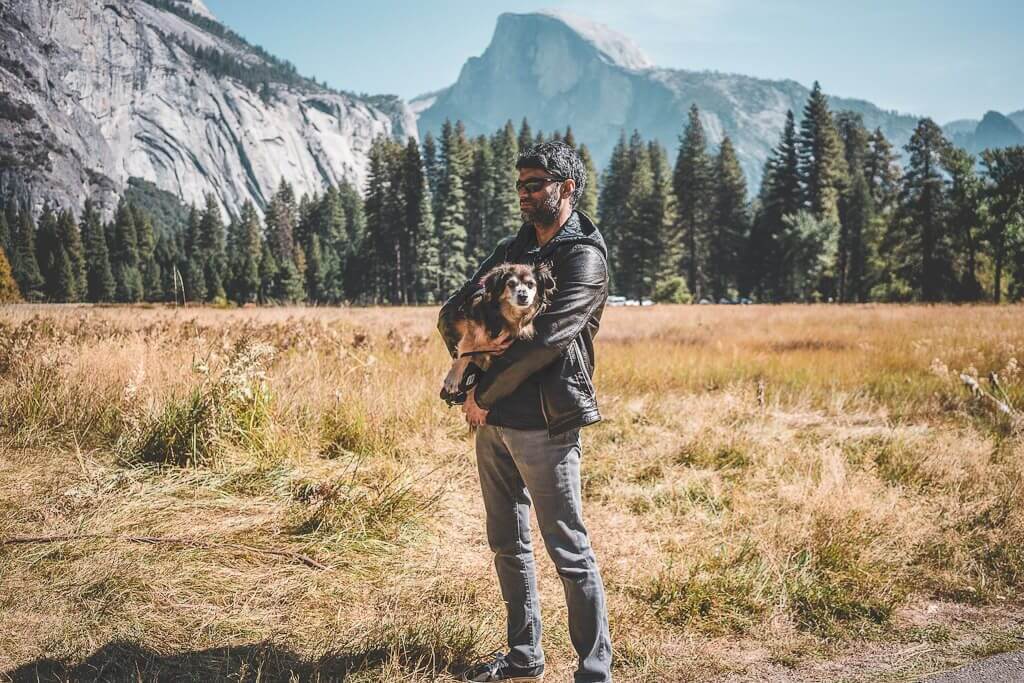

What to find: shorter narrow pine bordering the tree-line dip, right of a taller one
left=708, top=136, right=750, bottom=301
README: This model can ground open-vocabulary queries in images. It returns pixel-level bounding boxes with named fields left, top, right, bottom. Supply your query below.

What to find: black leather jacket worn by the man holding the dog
left=437, top=211, right=608, bottom=436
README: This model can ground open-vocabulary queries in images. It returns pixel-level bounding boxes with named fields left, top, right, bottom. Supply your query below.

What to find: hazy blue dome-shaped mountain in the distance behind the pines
left=411, top=12, right=916, bottom=190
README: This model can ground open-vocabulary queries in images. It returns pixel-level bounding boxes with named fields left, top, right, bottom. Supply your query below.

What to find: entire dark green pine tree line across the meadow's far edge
left=0, top=83, right=1024, bottom=304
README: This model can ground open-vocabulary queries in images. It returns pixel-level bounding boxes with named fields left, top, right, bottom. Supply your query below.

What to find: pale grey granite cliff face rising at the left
left=0, top=0, right=416, bottom=218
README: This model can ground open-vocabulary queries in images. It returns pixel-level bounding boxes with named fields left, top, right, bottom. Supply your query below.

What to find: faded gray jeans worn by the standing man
left=476, top=425, right=611, bottom=683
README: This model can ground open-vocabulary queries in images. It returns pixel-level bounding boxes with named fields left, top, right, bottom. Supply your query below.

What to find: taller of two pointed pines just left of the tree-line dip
left=673, top=104, right=714, bottom=299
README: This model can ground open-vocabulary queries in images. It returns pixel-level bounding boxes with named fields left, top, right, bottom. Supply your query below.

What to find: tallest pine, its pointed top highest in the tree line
left=798, top=81, right=847, bottom=222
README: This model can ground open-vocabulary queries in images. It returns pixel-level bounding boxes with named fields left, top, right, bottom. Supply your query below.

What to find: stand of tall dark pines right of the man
left=600, top=83, right=1024, bottom=302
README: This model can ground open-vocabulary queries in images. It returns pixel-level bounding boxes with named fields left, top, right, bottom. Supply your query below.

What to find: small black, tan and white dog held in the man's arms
left=441, top=263, right=555, bottom=405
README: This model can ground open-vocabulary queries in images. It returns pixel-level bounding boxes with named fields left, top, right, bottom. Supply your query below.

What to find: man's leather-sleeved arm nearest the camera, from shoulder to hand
left=475, top=245, right=608, bottom=410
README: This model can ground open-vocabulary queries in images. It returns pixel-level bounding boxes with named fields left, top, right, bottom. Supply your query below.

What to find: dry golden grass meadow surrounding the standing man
left=0, top=305, right=1024, bottom=681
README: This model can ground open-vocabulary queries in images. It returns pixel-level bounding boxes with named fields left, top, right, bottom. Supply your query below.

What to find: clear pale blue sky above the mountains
left=206, top=0, right=1024, bottom=123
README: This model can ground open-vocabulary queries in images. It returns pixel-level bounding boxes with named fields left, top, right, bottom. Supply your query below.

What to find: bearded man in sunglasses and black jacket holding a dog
left=437, top=142, right=611, bottom=683
